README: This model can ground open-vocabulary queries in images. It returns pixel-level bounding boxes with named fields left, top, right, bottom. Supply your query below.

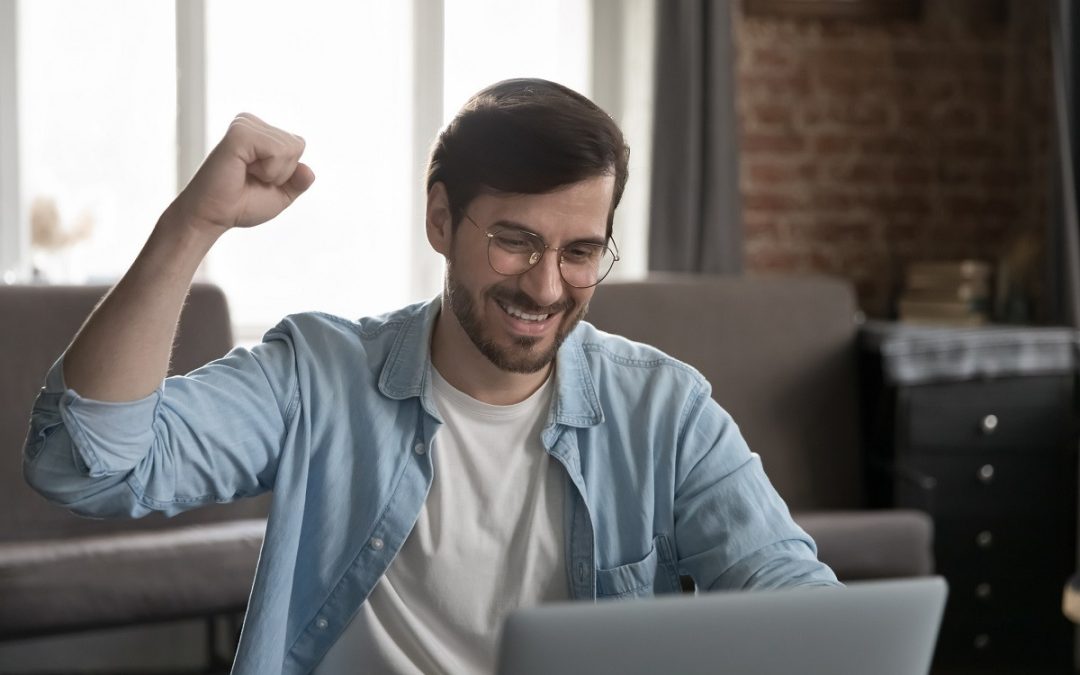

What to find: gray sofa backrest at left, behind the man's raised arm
left=0, top=284, right=266, bottom=542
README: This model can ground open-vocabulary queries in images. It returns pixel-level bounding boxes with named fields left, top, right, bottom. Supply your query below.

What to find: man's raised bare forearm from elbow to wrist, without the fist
left=64, top=206, right=217, bottom=401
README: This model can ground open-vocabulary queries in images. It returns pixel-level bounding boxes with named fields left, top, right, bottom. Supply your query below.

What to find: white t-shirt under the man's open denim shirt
left=314, top=368, right=569, bottom=675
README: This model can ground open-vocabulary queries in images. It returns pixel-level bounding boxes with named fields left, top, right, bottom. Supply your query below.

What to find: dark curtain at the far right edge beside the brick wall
left=1045, top=0, right=1080, bottom=327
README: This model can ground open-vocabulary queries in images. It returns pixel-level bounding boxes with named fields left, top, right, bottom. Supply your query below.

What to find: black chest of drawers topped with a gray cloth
left=862, top=324, right=1078, bottom=672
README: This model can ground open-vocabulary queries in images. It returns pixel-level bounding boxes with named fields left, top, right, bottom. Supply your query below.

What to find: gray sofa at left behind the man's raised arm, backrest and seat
left=0, top=284, right=268, bottom=649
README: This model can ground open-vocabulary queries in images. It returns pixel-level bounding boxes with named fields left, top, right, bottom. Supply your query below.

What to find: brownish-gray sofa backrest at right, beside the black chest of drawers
left=586, top=274, right=864, bottom=510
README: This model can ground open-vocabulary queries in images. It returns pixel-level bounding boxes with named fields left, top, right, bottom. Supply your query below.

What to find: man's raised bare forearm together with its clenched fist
left=64, top=112, right=315, bottom=402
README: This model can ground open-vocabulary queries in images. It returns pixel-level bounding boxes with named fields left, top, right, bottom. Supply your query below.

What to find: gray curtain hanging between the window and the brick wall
left=649, top=0, right=742, bottom=273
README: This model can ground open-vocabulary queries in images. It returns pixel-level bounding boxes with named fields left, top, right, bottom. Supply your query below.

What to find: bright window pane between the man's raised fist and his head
left=206, top=0, right=416, bottom=338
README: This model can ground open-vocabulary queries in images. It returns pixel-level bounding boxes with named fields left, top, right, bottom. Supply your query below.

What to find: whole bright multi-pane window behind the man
left=0, top=0, right=651, bottom=342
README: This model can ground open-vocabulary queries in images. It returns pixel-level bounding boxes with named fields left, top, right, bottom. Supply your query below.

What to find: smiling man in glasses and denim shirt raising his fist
left=25, top=80, right=836, bottom=675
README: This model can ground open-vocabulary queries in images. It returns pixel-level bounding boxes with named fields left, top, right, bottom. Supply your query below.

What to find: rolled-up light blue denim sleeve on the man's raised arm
left=23, top=329, right=299, bottom=517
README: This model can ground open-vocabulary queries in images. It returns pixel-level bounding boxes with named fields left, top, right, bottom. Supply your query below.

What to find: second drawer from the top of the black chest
left=895, top=453, right=1076, bottom=518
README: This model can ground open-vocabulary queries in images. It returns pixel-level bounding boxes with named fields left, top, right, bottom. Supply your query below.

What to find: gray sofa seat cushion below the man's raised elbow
left=0, top=518, right=266, bottom=638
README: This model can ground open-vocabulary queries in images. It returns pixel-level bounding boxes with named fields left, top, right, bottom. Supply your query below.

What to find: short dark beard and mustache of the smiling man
left=446, top=260, right=589, bottom=375
